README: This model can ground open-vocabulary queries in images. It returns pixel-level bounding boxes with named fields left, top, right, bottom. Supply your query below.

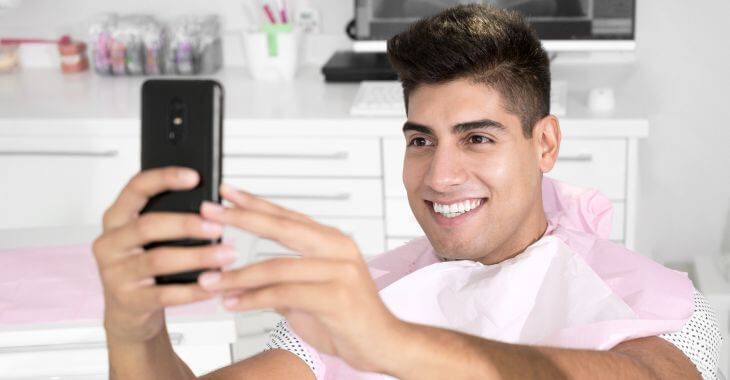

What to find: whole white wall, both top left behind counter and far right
left=0, top=0, right=730, bottom=261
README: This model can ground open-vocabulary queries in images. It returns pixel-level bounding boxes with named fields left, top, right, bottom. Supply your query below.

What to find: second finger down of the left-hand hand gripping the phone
left=94, top=212, right=223, bottom=267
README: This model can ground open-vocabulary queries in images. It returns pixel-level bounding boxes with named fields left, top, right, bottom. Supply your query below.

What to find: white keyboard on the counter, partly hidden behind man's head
left=350, top=81, right=568, bottom=116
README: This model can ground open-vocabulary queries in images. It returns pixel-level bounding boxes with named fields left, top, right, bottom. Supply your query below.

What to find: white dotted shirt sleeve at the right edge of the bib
left=659, top=290, right=723, bottom=380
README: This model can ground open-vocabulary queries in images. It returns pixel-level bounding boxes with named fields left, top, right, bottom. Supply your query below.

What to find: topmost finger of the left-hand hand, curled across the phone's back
left=103, top=166, right=199, bottom=231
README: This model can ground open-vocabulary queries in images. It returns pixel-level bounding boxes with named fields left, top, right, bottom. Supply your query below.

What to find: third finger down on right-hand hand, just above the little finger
left=198, top=257, right=350, bottom=290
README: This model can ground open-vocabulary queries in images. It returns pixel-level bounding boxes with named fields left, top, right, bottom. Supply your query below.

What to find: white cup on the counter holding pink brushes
left=243, top=24, right=300, bottom=82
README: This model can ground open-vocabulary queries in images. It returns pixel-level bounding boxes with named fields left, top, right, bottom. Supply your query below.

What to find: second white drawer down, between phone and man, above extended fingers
left=224, top=177, right=383, bottom=217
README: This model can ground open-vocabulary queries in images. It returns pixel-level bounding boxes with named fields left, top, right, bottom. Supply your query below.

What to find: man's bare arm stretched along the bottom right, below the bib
left=384, top=323, right=700, bottom=380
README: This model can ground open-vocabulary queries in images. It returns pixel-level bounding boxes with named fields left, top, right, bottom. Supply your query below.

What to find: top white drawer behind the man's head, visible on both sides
left=383, top=138, right=626, bottom=200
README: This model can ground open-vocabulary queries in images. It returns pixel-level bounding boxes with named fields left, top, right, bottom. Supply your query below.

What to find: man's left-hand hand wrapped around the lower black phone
left=93, top=167, right=235, bottom=343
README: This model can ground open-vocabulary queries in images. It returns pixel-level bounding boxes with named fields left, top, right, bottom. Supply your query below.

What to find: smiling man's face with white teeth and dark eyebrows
left=403, top=79, right=544, bottom=264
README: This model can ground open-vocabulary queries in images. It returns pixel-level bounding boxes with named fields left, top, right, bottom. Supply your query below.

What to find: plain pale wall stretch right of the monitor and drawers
left=635, top=0, right=730, bottom=261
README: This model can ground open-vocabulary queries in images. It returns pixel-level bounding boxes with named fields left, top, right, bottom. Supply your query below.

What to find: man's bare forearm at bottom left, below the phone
left=107, top=329, right=197, bottom=380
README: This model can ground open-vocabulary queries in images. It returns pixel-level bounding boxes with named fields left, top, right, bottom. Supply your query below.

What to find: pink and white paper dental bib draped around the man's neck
left=292, top=178, right=694, bottom=379
